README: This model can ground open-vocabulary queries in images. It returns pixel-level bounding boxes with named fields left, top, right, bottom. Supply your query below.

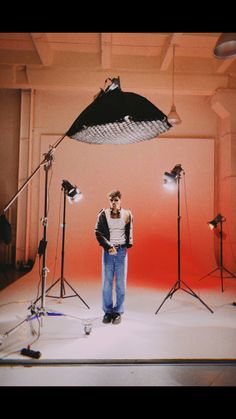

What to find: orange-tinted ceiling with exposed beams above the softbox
left=0, top=32, right=236, bottom=95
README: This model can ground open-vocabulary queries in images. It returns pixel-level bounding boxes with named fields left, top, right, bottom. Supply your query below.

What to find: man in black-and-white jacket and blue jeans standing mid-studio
left=95, top=190, right=133, bottom=324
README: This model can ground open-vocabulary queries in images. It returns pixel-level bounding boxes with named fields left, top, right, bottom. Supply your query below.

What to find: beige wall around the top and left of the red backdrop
left=30, top=88, right=217, bottom=268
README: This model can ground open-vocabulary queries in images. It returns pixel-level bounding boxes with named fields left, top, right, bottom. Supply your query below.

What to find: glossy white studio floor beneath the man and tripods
left=0, top=271, right=236, bottom=385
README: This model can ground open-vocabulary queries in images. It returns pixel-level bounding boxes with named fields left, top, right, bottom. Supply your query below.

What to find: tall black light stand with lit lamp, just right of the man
left=155, top=164, right=213, bottom=314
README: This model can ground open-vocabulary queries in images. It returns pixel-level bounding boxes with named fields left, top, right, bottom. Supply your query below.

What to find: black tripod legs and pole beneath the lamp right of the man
left=155, top=173, right=213, bottom=314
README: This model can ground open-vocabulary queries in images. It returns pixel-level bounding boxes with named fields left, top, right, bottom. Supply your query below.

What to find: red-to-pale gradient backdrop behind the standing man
left=36, top=135, right=216, bottom=288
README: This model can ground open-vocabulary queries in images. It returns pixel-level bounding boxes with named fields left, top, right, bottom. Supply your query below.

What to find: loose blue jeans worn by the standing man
left=102, top=247, right=128, bottom=314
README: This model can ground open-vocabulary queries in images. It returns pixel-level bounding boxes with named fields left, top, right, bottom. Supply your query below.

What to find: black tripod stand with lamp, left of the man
left=43, top=181, right=90, bottom=308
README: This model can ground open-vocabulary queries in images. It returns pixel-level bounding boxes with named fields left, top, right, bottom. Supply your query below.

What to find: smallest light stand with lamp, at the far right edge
left=199, top=214, right=236, bottom=292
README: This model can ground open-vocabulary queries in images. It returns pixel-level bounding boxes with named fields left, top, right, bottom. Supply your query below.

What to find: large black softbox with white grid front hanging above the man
left=66, top=79, right=172, bottom=144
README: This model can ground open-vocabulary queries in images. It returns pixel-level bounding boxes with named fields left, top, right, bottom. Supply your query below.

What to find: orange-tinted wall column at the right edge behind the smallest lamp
left=211, top=89, right=236, bottom=276
